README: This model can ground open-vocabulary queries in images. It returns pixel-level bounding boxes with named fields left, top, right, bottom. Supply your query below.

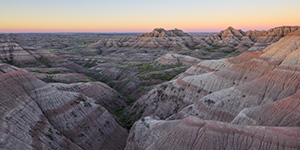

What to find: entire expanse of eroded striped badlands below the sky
left=0, top=26, right=300, bottom=150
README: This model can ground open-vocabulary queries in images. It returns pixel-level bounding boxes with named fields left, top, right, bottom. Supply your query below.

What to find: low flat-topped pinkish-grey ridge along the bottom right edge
left=126, top=117, right=300, bottom=150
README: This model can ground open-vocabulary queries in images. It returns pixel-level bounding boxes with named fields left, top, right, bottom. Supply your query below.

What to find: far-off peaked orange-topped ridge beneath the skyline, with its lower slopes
left=85, top=26, right=299, bottom=59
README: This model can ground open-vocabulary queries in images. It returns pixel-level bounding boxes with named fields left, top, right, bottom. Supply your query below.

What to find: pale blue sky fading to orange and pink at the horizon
left=0, top=0, right=300, bottom=33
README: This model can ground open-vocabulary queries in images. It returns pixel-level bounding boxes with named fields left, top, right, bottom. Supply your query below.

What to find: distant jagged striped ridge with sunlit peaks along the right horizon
left=87, top=26, right=299, bottom=52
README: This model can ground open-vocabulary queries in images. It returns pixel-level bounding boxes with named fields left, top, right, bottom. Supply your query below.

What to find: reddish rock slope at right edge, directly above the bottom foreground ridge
left=232, top=92, right=300, bottom=126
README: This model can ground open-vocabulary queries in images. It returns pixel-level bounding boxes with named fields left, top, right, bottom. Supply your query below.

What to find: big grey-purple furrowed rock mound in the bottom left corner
left=0, top=65, right=127, bottom=149
